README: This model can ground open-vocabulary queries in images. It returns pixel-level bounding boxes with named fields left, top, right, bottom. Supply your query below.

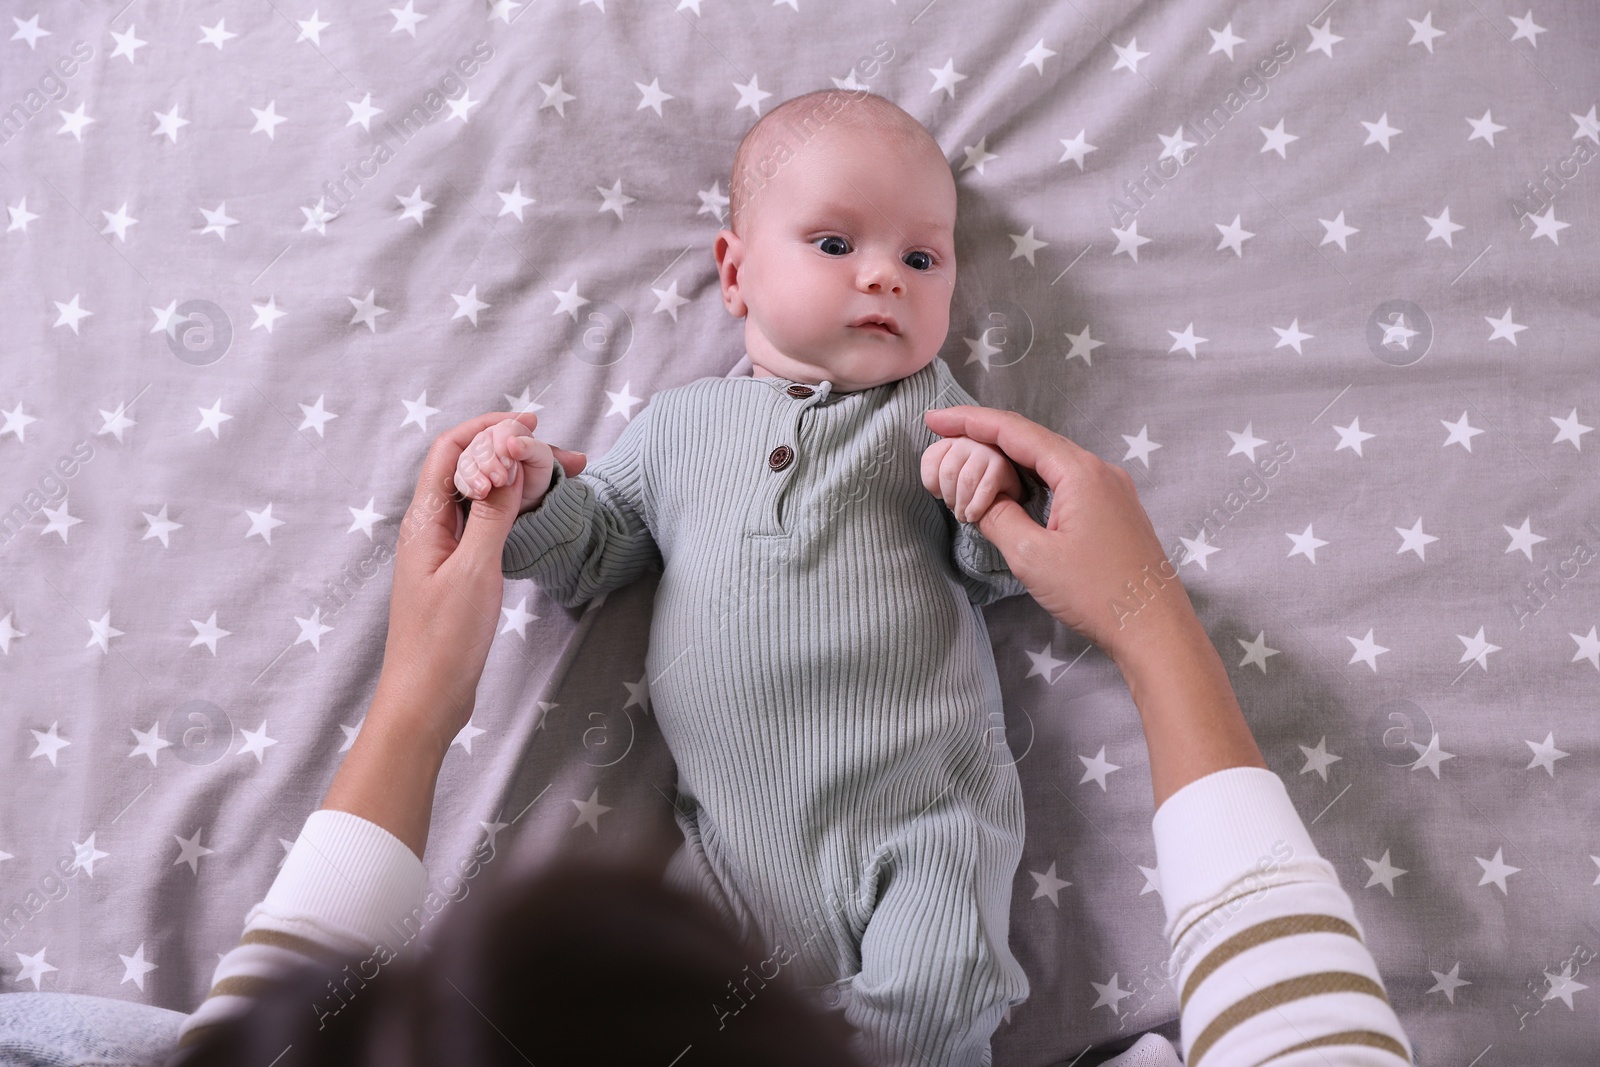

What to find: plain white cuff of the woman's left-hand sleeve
left=245, top=808, right=427, bottom=944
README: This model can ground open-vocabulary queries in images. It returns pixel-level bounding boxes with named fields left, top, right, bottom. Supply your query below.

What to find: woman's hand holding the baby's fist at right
left=925, top=405, right=1194, bottom=659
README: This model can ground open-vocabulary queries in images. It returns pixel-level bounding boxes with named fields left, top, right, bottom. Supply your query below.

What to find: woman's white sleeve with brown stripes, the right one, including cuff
left=1154, top=768, right=1411, bottom=1067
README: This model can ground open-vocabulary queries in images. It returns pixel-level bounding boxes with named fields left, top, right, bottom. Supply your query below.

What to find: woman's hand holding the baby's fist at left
left=374, top=411, right=586, bottom=752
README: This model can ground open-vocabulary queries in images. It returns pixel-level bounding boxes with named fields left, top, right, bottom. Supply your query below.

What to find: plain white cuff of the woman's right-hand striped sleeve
left=1150, top=766, right=1338, bottom=929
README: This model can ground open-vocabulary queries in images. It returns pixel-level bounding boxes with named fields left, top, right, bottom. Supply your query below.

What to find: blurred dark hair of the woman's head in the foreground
left=168, top=857, right=861, bottom=1067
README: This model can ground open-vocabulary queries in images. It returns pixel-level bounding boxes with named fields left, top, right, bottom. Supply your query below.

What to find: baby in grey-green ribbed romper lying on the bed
left=456, top=90, right=1048, bottom=1067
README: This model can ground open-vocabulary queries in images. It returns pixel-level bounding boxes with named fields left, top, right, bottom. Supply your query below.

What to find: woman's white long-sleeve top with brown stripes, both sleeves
left=178, top=768, right=1411, bottom=1067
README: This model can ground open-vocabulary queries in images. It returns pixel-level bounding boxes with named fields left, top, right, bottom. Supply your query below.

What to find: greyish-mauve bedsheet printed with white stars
left=0, top=0, right=1600, bottom=1067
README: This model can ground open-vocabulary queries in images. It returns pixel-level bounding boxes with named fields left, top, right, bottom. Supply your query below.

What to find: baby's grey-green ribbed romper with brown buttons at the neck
left=502, top=358, right=1048, bottom=1067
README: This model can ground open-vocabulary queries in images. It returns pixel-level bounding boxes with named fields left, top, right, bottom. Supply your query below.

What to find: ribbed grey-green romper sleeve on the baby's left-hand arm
left=501, top=403, right=661, bottom=608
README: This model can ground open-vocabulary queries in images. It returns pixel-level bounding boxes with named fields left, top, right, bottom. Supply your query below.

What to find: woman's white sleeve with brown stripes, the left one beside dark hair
left=178, top=808, right=427, bottom=1048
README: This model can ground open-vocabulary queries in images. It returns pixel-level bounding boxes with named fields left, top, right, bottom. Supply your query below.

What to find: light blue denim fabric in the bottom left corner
left=0, top=993, right=184, bottom=1067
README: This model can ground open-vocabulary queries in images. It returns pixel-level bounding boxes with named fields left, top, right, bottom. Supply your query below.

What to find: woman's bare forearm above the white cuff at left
left=322, top=681, right=451, bottom=859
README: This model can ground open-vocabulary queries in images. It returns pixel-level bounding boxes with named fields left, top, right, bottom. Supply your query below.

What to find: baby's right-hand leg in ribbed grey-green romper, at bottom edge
left=843, top=776, right=1027, bottom=1067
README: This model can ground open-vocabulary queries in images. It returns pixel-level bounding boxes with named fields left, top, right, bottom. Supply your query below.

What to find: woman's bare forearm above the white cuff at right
left=1112, top=601, right=1267, bottom=808
